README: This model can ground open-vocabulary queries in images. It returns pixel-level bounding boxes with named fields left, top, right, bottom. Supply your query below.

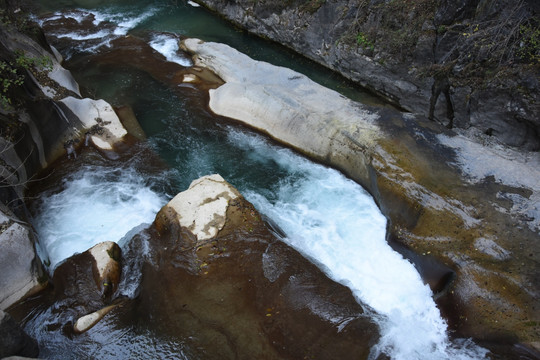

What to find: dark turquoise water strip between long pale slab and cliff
left=34, top=0, right=385, bottom=106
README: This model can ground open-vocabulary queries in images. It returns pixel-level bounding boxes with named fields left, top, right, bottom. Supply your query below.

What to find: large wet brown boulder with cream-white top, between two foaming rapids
left=147, top=175, right=378, bottom=359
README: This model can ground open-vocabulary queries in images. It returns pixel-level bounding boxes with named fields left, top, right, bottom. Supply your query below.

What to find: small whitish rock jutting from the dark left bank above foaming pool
left=61, top=96, right=127, bottom=150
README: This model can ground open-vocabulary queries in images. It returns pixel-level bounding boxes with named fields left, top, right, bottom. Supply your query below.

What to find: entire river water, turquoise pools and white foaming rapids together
left=28, top=0, right=486, bottom=359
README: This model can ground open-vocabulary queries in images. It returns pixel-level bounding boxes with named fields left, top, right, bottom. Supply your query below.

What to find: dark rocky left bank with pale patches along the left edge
left=0, top=9, right=131, bottom=309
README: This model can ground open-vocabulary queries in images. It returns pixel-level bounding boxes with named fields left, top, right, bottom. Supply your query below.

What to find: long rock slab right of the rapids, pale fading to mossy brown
left=180, top=39, right=540, bottom=352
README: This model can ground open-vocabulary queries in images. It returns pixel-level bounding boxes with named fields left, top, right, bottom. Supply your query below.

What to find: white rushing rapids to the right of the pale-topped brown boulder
left=229, top=131, right=487, bottom=360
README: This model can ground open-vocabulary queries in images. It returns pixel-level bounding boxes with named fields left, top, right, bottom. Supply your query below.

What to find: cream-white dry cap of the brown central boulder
left=164, top=174, right=240, bottom=241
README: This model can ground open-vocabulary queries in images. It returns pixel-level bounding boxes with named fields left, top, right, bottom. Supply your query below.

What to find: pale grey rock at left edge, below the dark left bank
left=0, top=218, right=43, bottom=310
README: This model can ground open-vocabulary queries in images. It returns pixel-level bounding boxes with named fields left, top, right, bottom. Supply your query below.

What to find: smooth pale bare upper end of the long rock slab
left=183, top=39, right=380, bottom=159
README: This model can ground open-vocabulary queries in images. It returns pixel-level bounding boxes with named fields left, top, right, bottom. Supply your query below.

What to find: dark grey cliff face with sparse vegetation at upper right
left=199, top=0, right=540, bottom=150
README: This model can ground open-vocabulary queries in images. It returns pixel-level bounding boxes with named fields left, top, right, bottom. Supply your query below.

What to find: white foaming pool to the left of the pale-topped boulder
left=34, top=167, right=166, bottom=272
